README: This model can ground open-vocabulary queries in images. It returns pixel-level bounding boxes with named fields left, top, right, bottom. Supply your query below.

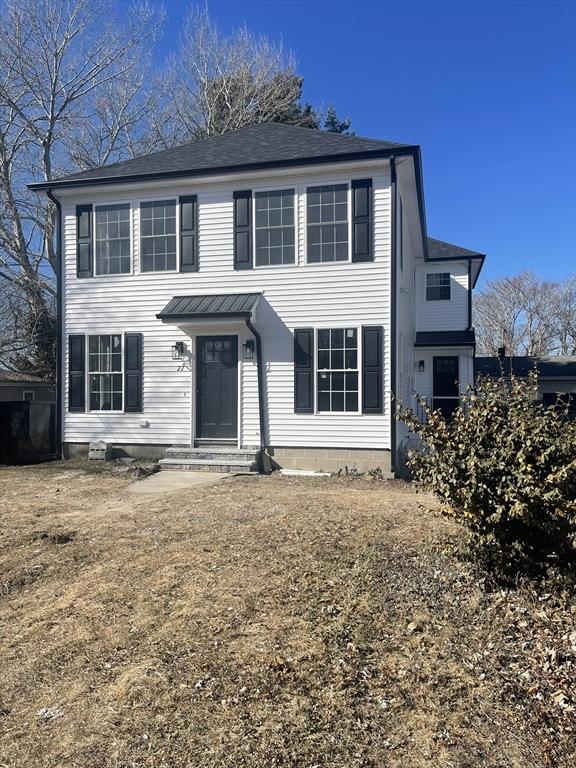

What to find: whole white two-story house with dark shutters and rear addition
left=30, top=124, right=484, bottom=471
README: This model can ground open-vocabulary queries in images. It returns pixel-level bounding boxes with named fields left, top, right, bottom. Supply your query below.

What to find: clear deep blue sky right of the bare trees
left=154, top=0, right=576, bottom=280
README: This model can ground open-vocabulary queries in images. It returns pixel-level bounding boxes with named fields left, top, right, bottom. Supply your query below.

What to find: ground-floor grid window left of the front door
left=88, top=334, right=123, bottom=411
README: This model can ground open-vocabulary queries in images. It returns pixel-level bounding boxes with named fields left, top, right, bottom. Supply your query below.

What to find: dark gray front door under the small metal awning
left=196, top=336, right=238, bottom=439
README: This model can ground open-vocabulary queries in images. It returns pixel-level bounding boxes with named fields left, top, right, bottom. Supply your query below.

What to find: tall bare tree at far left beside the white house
left=0, top=0, right=159, bottom=375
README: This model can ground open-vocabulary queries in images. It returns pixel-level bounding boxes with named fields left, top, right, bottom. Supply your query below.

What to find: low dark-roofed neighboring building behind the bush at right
left=475, top=349, right=576, bottom=412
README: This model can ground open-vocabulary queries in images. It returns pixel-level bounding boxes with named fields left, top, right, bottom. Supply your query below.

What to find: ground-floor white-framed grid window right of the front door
left=317, top=328, right=358, bottom=413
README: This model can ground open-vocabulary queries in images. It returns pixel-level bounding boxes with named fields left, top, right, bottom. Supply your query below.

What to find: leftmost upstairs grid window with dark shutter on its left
left=95, top=203, right=130, bottom=275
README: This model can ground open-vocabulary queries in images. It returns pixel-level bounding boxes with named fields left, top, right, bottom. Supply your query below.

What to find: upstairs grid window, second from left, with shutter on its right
left=140, top=200, right=176, bottom=272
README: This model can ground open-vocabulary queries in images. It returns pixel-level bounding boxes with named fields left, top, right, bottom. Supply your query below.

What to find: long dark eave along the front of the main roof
left=27, top=145, right=420, bottom=192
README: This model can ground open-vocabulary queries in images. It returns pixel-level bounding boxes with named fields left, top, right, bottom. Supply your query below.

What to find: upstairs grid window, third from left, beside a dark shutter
left=254, top=189, right=296, bottom=267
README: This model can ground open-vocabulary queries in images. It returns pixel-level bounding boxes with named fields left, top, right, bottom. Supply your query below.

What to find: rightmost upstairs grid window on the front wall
left=306, top=184, right=349, bottom=263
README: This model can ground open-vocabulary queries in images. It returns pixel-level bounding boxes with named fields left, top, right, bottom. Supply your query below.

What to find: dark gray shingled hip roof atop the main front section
left=30, top=123, right=411, bottom=189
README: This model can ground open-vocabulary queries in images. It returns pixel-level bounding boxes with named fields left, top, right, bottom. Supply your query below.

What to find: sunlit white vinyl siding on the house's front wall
left=63, top=165, right=390, bottom=449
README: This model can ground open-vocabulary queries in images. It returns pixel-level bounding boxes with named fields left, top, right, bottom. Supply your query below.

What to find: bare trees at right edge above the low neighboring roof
left=474, top=272, right=576, bottom=356
